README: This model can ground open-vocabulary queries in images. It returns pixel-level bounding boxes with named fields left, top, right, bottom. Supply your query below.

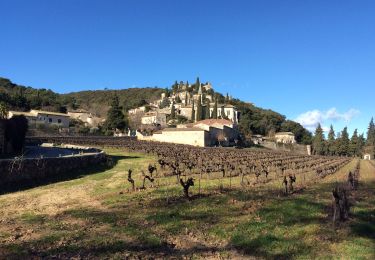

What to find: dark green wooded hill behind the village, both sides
left=0, top=78, right=311, bottom=144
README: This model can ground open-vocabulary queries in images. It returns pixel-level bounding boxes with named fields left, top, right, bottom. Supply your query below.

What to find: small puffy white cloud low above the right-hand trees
left=295, top=107, right=360, bottom=131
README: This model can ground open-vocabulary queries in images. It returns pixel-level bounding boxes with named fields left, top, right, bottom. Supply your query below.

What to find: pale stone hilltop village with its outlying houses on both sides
left=0, top=78, right=296, bottom=148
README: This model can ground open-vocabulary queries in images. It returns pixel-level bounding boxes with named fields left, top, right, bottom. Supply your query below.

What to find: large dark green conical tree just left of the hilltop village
left=105, top=95, right=128, bottom=131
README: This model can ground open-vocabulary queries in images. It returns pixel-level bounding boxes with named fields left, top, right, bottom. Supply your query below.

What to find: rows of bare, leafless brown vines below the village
left=30, top=137, right=351, bottom=197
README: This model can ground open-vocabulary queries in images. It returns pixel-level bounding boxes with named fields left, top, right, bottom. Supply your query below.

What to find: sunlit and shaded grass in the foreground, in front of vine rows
left=0, top=150, right=375, bottom=259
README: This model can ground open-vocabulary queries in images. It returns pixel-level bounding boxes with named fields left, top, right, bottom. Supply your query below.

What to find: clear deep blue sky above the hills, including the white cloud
left=0, top=0, right=375, bottom=136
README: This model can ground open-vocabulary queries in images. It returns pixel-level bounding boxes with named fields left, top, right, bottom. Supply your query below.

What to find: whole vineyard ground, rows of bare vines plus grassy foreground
left=0, top=137, right=375, bottom=259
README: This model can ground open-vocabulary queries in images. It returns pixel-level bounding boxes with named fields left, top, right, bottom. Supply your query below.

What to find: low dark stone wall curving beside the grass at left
left=0, top=152, right=107, bottom=187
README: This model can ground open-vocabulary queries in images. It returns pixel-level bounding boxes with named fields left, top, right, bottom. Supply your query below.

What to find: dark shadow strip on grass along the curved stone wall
left=0, top=155, right=131, bottom=195
